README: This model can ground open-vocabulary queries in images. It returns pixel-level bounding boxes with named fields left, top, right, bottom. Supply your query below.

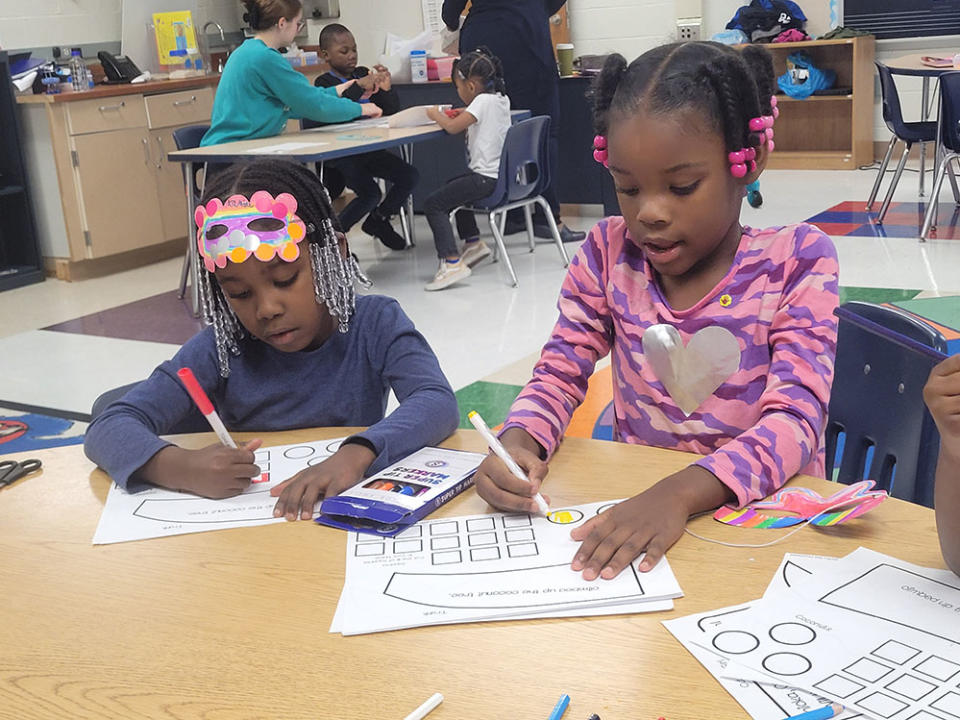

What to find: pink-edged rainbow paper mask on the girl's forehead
left=194, top=190, right=307, bottom=272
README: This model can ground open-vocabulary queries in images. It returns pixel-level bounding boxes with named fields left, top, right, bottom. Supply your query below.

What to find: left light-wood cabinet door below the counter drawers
left=71, top=128, right=163, bottom=258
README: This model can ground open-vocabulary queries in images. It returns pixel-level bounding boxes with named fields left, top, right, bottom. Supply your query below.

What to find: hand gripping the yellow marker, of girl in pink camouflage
left=474, top=428, right=550, bottom=513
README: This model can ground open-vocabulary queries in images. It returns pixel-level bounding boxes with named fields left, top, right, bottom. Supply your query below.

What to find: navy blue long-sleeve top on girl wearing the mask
left=84, top=295, right=460, bottom=487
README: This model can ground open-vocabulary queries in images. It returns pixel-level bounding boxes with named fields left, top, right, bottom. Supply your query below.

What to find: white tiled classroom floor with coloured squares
left=0, top=164, right=960, bottom=453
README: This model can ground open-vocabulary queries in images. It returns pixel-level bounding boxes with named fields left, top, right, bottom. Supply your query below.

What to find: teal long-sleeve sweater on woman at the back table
left=200, top=38, right=363, bottom=146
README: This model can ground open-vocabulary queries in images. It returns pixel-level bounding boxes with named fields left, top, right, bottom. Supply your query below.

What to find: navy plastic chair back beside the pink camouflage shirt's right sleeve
left=826, top=302, right=947, bottom=507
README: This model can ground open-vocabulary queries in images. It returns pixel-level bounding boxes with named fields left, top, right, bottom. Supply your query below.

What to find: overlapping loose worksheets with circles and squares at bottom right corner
left=664, top=549, right=960, bottom=720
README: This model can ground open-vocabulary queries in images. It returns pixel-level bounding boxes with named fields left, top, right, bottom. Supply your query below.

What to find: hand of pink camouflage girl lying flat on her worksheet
left=570, top=465, right=732, bottom=580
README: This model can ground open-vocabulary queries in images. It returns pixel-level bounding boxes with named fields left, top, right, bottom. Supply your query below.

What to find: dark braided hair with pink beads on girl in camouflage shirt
left=591, top=42, right=778, bottom=177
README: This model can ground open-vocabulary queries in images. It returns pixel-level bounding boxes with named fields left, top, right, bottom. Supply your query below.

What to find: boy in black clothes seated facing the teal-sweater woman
left=304, top=23, right=420, bottom=250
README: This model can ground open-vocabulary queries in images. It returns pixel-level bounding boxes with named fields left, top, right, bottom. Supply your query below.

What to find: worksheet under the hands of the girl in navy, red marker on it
left=93, top=438, right=345, bottom=545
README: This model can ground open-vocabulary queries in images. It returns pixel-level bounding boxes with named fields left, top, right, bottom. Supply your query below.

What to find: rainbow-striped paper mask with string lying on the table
left=713, top=480, right=887, bottom=529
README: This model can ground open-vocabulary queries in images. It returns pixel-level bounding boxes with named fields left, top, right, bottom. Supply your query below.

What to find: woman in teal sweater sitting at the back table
left=200, top=0, right=380, bottom=146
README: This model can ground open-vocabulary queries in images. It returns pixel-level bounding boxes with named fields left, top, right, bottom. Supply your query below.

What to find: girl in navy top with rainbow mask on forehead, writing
left=85, top=160, right=459, bottom=520
